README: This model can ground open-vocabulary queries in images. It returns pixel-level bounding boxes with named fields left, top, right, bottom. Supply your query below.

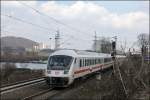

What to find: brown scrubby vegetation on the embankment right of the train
left=49, top=56, right=150, bottom=100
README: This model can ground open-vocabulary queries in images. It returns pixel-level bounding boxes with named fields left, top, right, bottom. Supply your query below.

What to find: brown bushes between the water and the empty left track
left=0, top=63, right=44, bottom=86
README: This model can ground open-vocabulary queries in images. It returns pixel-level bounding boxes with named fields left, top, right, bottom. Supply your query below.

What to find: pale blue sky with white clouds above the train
left=1, top=1, right=149, bottom=49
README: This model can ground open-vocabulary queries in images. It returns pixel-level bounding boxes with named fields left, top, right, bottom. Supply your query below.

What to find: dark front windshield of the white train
left=47, top=55, right=73, bottom=70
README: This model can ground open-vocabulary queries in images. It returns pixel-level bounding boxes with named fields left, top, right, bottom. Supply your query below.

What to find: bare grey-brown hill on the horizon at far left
left=1, top=36, right=38, bottom=48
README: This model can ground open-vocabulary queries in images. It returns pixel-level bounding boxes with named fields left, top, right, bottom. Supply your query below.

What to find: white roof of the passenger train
left=50, top=49, right=111, bottom=58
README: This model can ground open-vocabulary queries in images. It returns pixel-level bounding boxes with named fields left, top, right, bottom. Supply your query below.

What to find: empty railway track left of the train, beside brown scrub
left=0, top=77, right=44, bottom=94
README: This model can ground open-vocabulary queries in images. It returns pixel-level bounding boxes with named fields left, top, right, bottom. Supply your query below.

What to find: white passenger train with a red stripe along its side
left=45, top=50, right=124, bottom=87
